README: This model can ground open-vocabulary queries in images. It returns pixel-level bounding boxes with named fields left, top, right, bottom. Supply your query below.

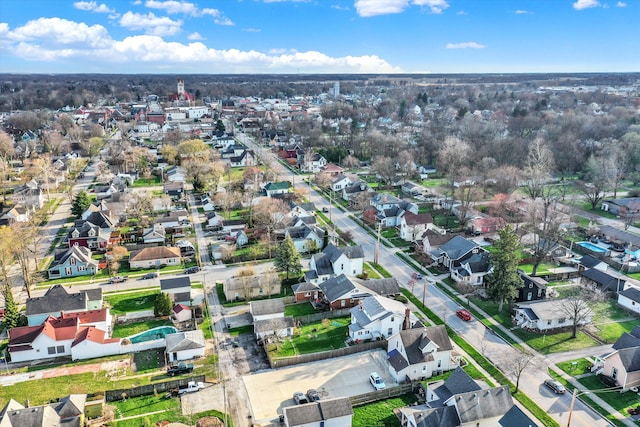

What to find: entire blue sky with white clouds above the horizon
left=0, top=0, right=640, bottom=74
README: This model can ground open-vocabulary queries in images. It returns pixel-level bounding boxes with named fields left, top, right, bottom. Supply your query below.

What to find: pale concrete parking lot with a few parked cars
left=242, top=350, right=396, bottom=424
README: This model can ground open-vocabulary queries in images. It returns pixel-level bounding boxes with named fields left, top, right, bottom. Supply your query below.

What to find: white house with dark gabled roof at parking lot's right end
left=387, top=325, right=459, bottom=383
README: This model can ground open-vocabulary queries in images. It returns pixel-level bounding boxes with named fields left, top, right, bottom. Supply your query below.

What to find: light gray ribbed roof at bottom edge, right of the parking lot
left=453, top=386, right=513, bottom=424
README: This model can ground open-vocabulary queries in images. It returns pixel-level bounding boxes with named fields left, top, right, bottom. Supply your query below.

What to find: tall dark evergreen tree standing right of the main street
left=488, top=225, right=522, bottom=311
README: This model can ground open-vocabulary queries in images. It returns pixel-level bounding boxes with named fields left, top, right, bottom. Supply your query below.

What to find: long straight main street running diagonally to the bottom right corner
left=238, top=130, right=609, bottom=427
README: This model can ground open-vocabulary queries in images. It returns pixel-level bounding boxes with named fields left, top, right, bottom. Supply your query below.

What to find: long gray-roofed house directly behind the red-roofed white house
left=25, top=285, right=102, bottom=326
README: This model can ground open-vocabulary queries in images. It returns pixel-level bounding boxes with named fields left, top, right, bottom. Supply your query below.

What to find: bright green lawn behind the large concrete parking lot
left=269, top=317, right=351, bottom=357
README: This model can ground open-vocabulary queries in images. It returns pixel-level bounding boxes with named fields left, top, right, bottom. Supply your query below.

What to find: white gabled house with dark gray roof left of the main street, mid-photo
left=305, top=243, right=364, bottom=284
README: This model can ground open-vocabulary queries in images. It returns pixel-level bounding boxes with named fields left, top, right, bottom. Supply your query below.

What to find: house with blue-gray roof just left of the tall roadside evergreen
left=431, top=236, right=491, bottom=286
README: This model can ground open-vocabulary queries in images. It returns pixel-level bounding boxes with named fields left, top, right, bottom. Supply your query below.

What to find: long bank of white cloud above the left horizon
left=0, top=19, right=403, bottom=73
